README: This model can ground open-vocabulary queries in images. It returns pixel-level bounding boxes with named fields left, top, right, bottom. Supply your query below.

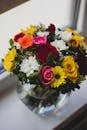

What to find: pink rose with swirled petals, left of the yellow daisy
left=41, top=66, right=54, bottom=86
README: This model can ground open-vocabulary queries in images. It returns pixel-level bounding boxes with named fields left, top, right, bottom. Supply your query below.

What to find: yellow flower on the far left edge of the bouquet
left=4, top=48, right=17, bottom=72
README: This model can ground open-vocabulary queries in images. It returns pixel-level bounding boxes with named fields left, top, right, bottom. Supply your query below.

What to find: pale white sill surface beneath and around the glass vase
left=0, top=81, right=87, bottom=130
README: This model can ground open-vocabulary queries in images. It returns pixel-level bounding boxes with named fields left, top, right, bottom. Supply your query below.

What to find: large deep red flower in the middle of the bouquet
left=36, top=44, right=59, bottom=63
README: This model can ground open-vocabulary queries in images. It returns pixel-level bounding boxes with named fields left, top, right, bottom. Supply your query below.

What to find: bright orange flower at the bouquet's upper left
left=18, top=34, right=33, bottom=49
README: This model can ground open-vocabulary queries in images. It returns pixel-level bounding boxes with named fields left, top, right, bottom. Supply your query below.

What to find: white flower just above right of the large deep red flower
left=51, top=40, right=68, bottom=50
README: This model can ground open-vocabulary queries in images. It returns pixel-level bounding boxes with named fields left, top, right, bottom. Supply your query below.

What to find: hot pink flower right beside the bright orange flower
left=33, top=36, right=47, bottom=45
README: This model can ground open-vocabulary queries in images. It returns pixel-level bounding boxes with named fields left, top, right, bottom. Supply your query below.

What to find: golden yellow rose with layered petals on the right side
left=62, top=56, right=79, bottom=83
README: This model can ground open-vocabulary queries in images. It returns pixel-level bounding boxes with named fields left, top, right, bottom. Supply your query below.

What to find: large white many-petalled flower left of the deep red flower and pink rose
left=20, top=56, right=40, bottom=77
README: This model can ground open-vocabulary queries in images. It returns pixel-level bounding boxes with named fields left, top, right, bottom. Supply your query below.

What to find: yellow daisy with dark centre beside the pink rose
left=51, top=66, right=66, bottom=88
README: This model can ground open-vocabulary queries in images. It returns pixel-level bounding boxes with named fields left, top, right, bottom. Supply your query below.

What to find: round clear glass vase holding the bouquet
left=17, top=83, right=70, bottom=116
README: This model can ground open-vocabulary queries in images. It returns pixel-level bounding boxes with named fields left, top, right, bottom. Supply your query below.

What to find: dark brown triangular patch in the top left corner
left=0, top=0, right=29, bottom=14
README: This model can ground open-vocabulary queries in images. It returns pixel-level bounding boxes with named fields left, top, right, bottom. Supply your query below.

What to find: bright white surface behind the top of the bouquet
left=0, top=0, right=76, bottom=59
